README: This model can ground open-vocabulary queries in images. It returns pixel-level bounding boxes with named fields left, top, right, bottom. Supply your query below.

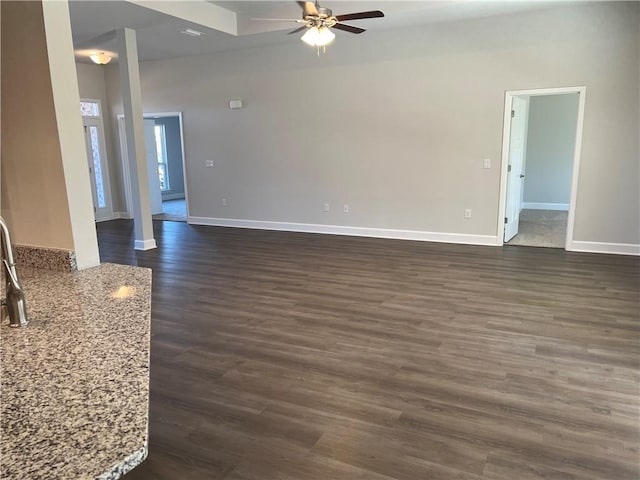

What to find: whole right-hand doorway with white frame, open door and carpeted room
left=498, top=87, right=586, bottom=250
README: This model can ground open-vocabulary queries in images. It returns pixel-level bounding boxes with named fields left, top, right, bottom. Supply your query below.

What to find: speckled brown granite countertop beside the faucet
left=0, top=264, right=151, bottom=480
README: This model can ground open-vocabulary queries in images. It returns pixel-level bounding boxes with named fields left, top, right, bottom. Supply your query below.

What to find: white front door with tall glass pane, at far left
left=82, top=117, right=113, bottom=222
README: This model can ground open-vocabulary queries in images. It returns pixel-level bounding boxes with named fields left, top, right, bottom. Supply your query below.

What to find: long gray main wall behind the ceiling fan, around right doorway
left=106, top=2, right=640, bottom=249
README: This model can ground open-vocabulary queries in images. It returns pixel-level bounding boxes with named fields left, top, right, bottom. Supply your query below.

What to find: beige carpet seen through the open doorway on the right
left=507, top=210, right=568, bottom=248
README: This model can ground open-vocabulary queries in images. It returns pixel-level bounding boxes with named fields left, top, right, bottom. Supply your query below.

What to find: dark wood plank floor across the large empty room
left=98, top=220, right=640, bottom=480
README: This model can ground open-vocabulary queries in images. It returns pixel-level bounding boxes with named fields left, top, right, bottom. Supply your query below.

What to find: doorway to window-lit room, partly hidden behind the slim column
left=118, top=112, right=188, bottom=222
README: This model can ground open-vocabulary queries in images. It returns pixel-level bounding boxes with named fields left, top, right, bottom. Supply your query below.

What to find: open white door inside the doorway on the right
left=504, top=97, right=529, bottom=242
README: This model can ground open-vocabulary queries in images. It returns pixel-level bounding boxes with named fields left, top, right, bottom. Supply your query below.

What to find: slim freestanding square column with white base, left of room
left=116, top=28, right=156, bottom=250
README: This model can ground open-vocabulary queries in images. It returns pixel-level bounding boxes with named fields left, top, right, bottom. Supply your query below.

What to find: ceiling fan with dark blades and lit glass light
left=252, top=0, right=384, bottom=48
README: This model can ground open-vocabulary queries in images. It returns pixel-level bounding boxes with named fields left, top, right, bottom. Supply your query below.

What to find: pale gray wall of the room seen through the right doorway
left=524, top=94, right=579, bottom=204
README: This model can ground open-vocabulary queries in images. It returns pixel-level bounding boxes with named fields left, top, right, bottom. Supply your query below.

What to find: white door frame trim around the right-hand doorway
left=497, top=85, right=587, bottom=250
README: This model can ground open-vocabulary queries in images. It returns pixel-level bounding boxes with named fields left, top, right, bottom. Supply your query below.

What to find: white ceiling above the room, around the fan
left=69, top=0, right=575, bottom=61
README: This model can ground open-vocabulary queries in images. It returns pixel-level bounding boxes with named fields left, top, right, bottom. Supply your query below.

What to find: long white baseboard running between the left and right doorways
left=187, top=216, right=500, bottom=246
